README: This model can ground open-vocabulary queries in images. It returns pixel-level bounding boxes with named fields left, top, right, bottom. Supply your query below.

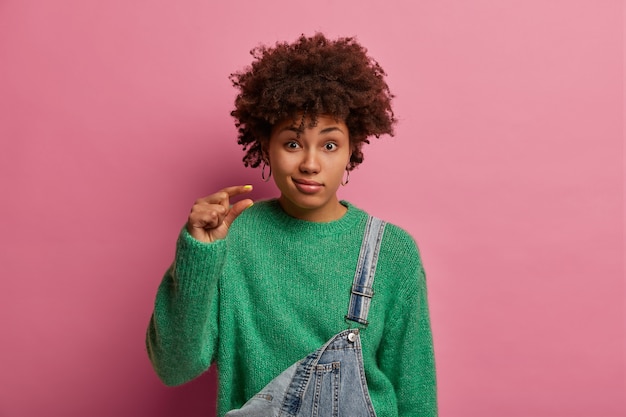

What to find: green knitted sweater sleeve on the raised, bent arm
left=146, top=229, right=226, bottom=385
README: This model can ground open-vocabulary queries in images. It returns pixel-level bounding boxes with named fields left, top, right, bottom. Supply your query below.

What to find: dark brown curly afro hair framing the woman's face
left=230, top=33, right=396, bottom=170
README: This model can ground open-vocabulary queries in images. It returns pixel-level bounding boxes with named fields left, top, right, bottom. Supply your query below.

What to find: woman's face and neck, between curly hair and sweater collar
left=266, top=116, right=351, bottom=221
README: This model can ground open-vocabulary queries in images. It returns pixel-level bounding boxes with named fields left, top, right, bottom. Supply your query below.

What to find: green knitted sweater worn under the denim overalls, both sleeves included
left=146, top=200, right=437, bottom=417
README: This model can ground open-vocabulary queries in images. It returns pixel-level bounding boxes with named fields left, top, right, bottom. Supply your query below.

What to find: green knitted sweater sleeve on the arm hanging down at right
left=379, top=242, right=437, bottom=417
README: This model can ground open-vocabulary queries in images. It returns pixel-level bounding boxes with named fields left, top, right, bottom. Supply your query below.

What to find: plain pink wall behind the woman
left=0, top=0, right=626, bottom=417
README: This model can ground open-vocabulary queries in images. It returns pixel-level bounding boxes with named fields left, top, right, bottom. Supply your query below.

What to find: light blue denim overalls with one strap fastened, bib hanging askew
left=226, top=216, right=385, bottom=417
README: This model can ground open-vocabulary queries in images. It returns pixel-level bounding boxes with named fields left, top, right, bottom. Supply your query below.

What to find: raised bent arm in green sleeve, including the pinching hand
left=146, top=186, right=252, bottom=385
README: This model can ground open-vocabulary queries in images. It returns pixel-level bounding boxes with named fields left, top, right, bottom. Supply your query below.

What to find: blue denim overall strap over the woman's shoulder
left=346, top=216, right=386, bottom=326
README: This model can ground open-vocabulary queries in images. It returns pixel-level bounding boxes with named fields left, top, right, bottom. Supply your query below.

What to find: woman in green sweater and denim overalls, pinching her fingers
left=147, top=34, right=437, bottom=417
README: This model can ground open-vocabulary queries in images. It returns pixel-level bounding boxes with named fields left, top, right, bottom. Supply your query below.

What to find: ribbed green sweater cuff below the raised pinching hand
left=171, top=227, right=226, bottom=296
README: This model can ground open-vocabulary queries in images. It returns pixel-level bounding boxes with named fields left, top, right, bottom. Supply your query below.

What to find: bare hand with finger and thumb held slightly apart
left=187, top=185, right=253, bottom=243
